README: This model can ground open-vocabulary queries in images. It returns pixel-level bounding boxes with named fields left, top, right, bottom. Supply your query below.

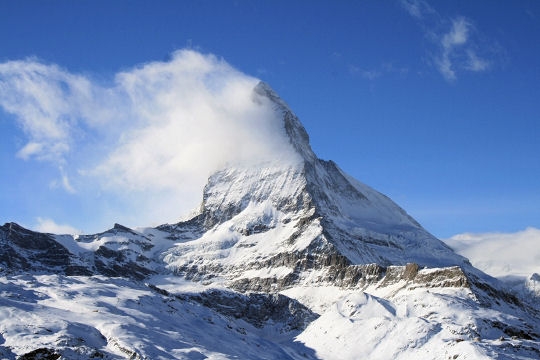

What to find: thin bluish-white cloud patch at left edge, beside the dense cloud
left=0, top=59, right=96, bottom=162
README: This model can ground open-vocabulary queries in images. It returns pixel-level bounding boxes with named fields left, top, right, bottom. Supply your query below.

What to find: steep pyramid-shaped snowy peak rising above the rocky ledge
left=161, top=83, right=467, bottom=291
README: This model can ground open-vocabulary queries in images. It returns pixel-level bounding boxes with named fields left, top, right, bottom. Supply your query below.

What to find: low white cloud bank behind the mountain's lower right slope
left=445, top=228, right=540, bottom=277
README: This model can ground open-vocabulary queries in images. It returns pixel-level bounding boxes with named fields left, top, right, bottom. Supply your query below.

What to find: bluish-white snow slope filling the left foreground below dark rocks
left=0, top=275, right=313, bottom=360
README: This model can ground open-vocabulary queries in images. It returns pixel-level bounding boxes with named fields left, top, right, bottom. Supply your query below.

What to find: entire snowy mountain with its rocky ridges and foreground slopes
left=0, top=83, right=540, bottom=359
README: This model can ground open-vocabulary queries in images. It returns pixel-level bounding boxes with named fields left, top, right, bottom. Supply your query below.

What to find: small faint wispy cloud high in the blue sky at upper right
left=401, top=0, right=492, bottom=82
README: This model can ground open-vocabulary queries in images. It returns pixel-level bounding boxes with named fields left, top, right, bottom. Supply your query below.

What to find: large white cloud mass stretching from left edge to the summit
left=0, top=50, right=297, bottom=225
